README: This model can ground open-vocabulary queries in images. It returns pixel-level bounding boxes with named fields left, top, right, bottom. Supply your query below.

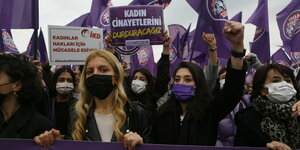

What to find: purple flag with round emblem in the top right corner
left=276, top=0, right=300, bottom=52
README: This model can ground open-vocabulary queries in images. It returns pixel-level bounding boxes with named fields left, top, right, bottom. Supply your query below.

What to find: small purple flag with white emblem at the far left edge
left=0, top=29, right=19, bottom=54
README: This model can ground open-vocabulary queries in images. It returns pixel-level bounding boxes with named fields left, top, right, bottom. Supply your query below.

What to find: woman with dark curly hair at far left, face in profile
left=0, top=54, right=51, bottom=139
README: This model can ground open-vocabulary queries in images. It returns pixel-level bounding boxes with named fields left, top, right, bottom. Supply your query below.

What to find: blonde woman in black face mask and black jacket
left=34, top=50, right=151, bottom=149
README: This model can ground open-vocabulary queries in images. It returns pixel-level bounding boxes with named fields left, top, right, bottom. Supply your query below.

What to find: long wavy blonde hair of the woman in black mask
left=72, top=50, right=127, bottom=140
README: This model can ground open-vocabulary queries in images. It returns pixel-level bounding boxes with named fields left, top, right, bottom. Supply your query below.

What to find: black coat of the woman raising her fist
left=153, top=62, right=247, bottom=146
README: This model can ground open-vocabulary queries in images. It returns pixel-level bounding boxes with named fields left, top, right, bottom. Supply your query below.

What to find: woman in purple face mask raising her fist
left=153, top=21, right=247, bottom=146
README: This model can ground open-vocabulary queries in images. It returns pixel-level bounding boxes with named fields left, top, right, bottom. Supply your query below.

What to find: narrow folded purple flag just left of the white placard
left=38, top=29, right=49, bottom=63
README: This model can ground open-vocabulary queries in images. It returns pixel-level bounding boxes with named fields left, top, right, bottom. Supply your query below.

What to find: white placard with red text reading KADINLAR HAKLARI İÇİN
left=48, top=25, right=103, bottom=65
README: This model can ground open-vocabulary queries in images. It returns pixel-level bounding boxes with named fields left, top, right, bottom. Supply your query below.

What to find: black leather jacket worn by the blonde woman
left=71, top=101, right=152, bottom=143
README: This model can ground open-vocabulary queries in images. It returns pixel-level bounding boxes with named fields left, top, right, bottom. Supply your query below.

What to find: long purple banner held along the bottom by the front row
left=0, top=139, right=268, bottom=150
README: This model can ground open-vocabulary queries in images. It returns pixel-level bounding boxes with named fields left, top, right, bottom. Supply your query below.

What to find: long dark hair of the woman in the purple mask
left=158, top=62, right=212, bottom=119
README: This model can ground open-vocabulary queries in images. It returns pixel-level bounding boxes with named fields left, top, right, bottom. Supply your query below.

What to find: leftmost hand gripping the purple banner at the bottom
left=34, top=129, right=61, bottom=147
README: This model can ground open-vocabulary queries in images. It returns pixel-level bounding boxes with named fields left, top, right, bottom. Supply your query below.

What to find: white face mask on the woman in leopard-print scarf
left=265, top=81, right=297, bottom=103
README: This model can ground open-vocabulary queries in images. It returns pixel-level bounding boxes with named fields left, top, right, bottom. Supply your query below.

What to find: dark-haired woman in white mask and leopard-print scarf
left=235, top=64, right=300, bottom=150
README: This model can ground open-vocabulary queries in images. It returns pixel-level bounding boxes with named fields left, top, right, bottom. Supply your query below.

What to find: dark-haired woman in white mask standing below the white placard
left=51, top=67, right=77, bottom=135
